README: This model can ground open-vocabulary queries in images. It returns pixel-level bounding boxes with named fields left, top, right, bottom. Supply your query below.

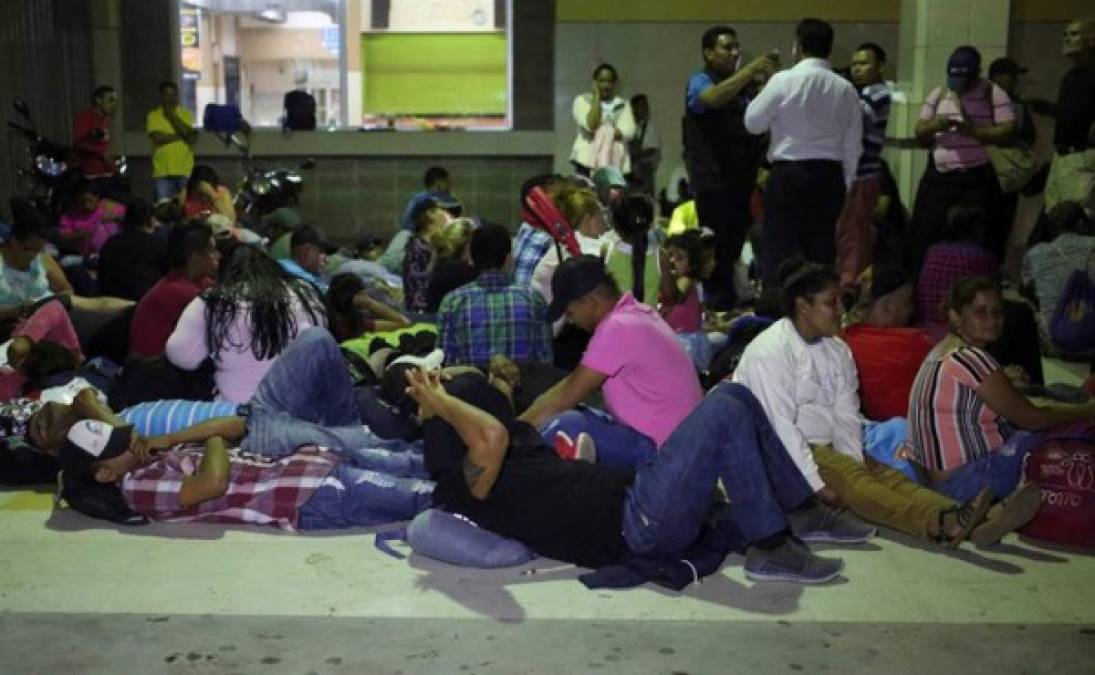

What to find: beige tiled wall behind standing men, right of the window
left=555, top=22, right=898, bottom=185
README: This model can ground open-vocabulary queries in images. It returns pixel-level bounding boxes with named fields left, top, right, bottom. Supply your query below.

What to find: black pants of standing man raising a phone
left=695, top=183, right=752, bottom=310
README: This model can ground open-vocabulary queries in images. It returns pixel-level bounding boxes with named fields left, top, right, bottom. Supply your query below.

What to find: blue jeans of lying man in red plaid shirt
left=297, top=461, right=434, bottom=530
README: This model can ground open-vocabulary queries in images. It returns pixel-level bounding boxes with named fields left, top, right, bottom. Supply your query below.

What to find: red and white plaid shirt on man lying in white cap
left=122, top=445, right=338, bottom=530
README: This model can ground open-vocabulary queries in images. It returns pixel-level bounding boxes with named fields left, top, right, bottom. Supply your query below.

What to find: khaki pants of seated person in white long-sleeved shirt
left=810, top=445, right=957, bottom=539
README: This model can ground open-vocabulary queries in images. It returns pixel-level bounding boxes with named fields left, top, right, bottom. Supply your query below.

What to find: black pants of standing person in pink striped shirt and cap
left=906, top=159, right=1011, bottom=273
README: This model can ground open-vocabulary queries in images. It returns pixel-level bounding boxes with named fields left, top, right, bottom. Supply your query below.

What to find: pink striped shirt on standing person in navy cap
left=920, top=80, right=1015, bottom=173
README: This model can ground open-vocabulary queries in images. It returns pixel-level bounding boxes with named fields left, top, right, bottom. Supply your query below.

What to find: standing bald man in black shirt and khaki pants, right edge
left=1046, top=18, right=1095, bottom=210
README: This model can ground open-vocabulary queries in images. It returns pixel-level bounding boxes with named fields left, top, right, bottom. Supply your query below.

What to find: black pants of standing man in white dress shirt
left=761, top=160, right=848, bottom=282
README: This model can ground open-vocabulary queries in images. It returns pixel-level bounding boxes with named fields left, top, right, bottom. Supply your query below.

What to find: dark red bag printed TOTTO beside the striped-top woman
left=1019, top=438, right=1095, bottom=548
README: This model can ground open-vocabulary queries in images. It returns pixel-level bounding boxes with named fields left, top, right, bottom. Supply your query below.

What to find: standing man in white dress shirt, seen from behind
left=745, top=19, right=863, bottom=279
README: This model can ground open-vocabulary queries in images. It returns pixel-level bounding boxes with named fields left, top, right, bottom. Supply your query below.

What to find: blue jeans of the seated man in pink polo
left=540, top=407, right=658, bottom=469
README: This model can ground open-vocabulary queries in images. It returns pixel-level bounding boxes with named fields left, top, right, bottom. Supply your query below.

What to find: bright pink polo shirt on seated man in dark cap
left=581, top=293, right=703, bottom=447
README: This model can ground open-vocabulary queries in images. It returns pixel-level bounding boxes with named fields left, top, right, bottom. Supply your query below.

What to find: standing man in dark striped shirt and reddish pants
left=837, top=43, right=890, bottom=288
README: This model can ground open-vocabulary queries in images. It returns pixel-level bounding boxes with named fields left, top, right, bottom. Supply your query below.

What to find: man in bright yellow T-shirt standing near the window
left=145, top=82, right=198, bottom=199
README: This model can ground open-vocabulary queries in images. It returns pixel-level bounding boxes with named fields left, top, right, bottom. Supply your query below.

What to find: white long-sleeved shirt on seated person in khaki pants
left=734, top=319, right=863, bottom=491
